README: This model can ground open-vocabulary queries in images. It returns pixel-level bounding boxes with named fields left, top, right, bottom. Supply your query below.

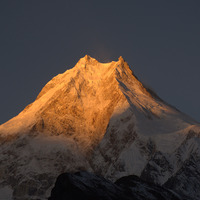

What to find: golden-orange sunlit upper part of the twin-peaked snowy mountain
left=0, top=55, right=161, bottom=146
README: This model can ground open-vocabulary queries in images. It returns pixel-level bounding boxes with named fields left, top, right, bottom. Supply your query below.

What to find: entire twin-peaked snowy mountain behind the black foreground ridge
left=0, top=56, right=200, bottom=200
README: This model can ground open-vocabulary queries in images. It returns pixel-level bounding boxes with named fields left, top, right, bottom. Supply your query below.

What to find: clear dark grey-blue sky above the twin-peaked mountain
left=0, top=0, right=200, bottom=124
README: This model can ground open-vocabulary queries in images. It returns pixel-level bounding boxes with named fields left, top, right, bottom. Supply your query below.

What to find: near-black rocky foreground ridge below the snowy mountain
left=48, top=172, right=181, bottom=200
